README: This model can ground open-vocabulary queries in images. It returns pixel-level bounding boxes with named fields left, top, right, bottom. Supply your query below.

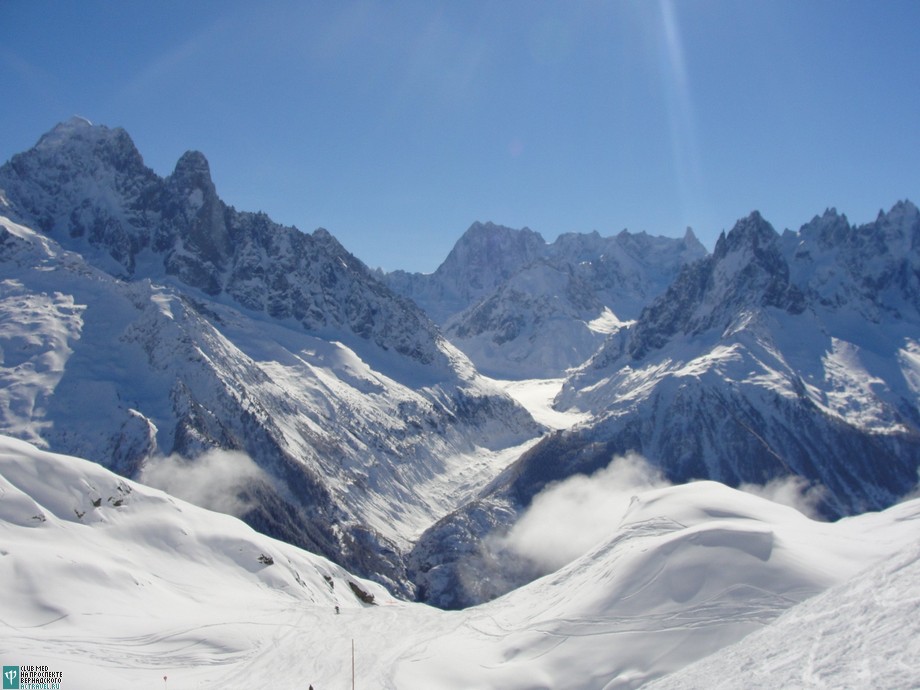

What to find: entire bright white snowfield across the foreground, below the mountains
left=0, top=437, right=920, bottom=690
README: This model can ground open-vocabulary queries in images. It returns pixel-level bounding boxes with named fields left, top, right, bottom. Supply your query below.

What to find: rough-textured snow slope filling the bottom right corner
left=646, top=542, right=920, bottom=690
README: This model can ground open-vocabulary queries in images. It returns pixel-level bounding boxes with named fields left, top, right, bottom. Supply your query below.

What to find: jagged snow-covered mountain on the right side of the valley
left=410, top=202, right=920, bottom=606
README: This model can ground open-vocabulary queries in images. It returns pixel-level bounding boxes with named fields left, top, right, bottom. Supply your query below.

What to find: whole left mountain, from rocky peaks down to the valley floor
left=0, top=119, right=540, bottom=593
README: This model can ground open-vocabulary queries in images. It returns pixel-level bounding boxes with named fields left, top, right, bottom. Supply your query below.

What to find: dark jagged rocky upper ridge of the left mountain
left=0, top=118, right=452, bottom=375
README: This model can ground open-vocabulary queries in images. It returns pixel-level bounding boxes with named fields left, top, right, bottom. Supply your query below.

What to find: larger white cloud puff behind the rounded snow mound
left=501, top=453, right=670, bottom=572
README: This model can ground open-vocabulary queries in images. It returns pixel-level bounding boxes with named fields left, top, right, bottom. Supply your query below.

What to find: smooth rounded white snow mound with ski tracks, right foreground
left=396, top=482, right=920, bottom=689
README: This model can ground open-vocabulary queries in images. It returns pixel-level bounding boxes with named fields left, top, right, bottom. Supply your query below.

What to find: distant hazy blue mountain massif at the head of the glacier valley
left=384, top=223, right=706, bottom=379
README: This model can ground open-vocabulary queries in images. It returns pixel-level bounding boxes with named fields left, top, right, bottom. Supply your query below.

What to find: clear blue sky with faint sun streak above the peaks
left=0, top=0, right=920, bottom=271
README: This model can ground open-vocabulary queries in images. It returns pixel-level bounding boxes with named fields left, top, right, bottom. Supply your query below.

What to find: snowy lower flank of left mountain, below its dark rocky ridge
left=0, top=210, right=539, bottom=592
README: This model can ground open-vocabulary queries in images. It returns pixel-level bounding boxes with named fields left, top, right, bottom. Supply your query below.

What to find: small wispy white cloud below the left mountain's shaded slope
left=140, top=449, right=270, bottom=517
